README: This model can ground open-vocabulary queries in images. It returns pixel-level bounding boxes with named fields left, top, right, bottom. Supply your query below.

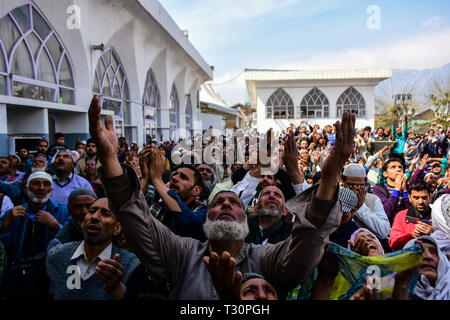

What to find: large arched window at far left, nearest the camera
left=0, top=3, right=75, bottom=104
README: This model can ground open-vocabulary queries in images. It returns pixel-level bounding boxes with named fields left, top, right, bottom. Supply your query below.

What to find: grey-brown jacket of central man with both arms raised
left=100, top=165, right=342, bottom=300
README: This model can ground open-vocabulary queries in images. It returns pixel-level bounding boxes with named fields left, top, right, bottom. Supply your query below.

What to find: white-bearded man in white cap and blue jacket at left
left=0, top=171, right=70, bottom=300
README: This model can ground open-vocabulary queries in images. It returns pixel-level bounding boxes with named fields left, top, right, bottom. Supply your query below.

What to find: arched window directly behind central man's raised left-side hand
left=92, top=48, right=131, bottom=142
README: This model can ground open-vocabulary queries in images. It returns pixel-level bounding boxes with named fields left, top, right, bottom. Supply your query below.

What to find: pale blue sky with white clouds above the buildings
left=160, top=0, right=450, bottom=105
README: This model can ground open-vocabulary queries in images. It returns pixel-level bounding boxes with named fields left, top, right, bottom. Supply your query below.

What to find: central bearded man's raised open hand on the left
left=88, top=95, right=123, bottom=178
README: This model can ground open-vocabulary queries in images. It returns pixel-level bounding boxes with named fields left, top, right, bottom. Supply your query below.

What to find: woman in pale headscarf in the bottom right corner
left=404, top=236, right=450, bottom=300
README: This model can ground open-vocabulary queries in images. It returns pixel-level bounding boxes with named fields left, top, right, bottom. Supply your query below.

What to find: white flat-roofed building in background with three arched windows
left=245, top=69, right=392, bottom=132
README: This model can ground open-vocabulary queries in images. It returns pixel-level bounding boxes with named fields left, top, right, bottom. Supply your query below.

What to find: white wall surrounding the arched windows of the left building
left=0, top=0, right=212, bottom=149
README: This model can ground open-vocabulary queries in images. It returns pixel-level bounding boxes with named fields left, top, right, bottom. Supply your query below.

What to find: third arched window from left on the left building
left=143, top=69, right=161, bottom=143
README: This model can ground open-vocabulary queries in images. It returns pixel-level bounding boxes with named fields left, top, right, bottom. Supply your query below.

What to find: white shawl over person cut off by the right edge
left=431, top=194, right=450, bottom=260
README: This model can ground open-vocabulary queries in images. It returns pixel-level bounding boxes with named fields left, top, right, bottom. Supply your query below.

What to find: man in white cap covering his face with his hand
left=341, top=163, right=391, bottom=241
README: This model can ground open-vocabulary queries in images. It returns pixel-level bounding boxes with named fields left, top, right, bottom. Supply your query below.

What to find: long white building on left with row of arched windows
left=0, top=0, right=213, bottom=155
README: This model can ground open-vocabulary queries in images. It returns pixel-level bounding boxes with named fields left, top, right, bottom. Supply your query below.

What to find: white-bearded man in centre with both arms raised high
left=89, top=96, right=355, bottom=300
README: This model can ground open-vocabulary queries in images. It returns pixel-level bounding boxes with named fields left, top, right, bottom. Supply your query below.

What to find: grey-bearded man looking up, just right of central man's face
left=245, top=186, right=294, bottom=245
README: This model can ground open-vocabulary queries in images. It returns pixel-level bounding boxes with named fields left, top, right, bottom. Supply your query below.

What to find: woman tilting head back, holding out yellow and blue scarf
left=302, top=228, right=420, bottom=300
